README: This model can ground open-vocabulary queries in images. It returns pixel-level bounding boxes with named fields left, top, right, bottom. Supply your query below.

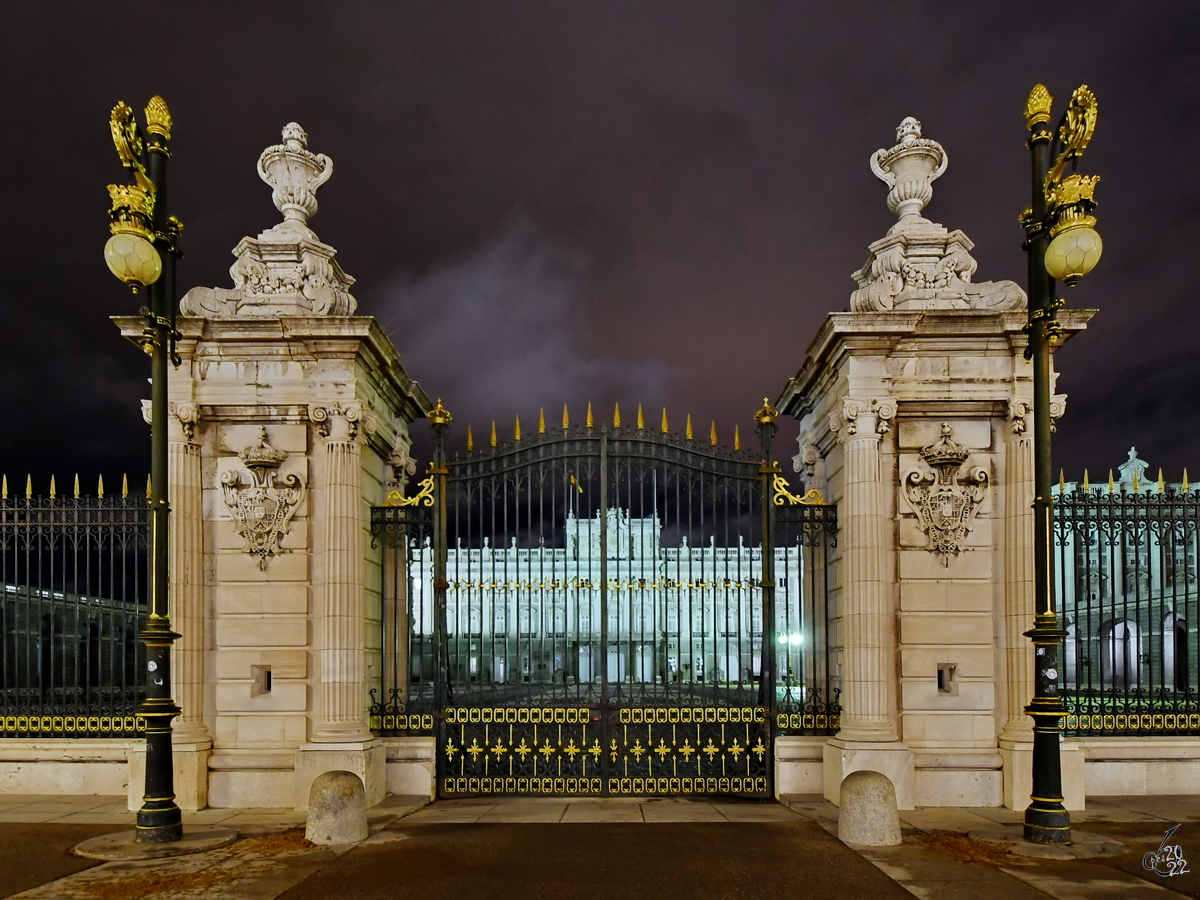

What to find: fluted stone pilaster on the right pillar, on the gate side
left=838, top=400, right=898, bottom=742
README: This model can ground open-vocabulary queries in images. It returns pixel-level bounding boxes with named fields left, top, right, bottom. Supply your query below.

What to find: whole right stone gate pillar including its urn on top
left=776, top=119, right=1092, bottom=809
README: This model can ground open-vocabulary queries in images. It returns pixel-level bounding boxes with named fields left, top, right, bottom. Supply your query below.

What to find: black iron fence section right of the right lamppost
left=1054, top=482, right=1200, bottom=736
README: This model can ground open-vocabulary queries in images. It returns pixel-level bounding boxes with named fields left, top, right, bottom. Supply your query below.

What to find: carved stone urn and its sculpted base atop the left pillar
left=180, top=122, right=358, bottom=317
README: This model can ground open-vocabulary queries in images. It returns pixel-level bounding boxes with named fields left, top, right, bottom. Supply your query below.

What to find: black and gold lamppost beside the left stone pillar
left=104, top=97, right=184, bottom=842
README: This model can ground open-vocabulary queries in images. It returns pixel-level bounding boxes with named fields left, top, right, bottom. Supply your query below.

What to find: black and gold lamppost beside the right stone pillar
left=1021, top=84, right=1102, bottom=844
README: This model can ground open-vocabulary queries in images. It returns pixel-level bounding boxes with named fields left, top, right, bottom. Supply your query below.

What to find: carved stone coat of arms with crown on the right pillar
left=901, top=422, right=988, bottom=565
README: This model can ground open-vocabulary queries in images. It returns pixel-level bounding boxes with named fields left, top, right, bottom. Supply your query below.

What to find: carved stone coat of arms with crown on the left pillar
left=221, top=428, right=305, bottom=571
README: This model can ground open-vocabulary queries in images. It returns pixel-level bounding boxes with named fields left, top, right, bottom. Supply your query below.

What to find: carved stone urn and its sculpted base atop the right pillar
left=850, top=116, right=1026, bottom=312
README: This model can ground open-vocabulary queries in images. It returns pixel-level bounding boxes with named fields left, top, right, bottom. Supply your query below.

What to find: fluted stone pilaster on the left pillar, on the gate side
left=310, top=403, right=371, bottom=743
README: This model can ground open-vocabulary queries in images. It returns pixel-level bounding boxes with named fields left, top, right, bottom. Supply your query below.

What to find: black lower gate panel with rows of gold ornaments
left=439, top=707, right=772, bottom=797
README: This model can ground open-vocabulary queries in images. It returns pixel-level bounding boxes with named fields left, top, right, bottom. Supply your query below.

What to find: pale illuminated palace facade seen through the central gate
left=409, top=509, right=811, bottom=686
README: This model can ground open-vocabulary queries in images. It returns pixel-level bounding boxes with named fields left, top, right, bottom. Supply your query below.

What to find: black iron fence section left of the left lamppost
left=0, top=485, right=150, bottom=738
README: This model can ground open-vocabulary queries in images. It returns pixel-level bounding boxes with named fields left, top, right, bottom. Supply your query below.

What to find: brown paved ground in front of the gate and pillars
left=0, top=794, right=1200, bottom=900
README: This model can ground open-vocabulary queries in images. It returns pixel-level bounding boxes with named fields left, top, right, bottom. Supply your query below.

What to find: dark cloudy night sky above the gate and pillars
left=0, top=0, right=1200, bottom=494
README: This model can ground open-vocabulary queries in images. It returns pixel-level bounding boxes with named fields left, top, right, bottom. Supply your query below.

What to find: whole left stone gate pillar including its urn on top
left=118, top=122, right=431, bottom=809
